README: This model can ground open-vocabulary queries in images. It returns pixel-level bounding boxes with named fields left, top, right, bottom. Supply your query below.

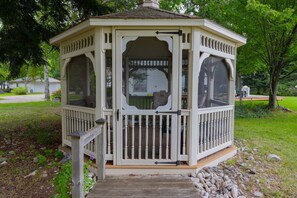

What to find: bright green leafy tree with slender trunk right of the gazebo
left=163, top=0, right=297, bottom=108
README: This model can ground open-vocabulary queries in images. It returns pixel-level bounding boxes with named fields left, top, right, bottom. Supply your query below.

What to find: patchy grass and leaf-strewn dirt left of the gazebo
left=0, top=102, right=63, bottom=197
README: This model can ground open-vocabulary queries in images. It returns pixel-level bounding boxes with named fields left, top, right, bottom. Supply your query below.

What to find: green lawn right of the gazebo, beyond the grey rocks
left=235, top=97, right=297, bottom=197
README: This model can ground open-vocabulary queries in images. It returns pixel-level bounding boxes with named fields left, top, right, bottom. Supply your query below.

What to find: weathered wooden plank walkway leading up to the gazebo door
left=87, top=175, right=199, bottom=198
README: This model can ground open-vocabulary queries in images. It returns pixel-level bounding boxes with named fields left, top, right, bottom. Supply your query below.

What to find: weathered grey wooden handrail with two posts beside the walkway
left=69, top=119, right=105, bottom=198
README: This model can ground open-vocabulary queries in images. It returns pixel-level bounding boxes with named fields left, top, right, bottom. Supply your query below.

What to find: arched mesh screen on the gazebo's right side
left=198, top=56, right=229, bottom=108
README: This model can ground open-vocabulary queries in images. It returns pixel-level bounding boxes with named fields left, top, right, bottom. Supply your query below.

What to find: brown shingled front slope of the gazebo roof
left=91, top=6, right=199, bottom=19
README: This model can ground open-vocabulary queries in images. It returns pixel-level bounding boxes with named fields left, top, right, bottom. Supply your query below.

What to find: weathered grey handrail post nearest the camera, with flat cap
left=69, top=131, right=85, bottom=198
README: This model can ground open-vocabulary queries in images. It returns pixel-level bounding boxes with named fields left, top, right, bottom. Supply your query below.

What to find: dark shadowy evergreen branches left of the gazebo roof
left=0, top=0, right=111, bottom=77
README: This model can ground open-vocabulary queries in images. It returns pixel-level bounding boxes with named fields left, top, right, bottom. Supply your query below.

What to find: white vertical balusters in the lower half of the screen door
left=121, top=110, right=172, bottom=162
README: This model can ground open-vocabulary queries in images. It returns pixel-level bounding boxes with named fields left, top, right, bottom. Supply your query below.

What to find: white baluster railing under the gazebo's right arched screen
left=197, top=105, right=234, bottom=160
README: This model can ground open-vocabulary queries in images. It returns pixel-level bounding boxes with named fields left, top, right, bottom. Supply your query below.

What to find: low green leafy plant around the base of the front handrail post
left=54, top=161, right=95, bottom=198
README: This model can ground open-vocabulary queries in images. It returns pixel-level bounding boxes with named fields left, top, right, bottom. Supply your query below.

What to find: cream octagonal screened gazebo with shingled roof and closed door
left=51, top=0, right=246, bottom=174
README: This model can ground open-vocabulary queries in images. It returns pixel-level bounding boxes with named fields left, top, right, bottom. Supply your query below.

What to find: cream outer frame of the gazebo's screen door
left=114, top=29, right=181, bottom=165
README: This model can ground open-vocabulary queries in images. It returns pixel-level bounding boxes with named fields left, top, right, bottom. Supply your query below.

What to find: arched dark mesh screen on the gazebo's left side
left=67, top=55, right=96, bottom=108
